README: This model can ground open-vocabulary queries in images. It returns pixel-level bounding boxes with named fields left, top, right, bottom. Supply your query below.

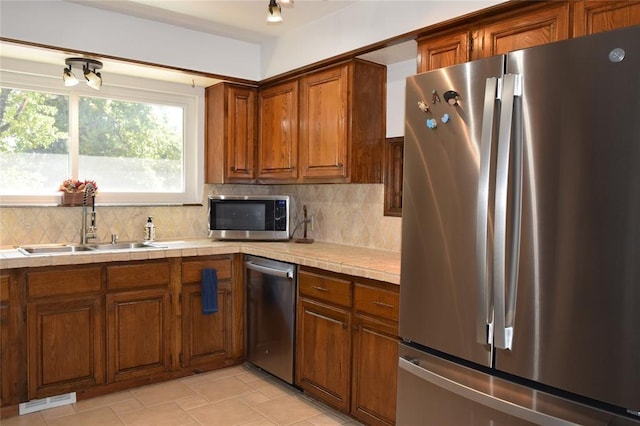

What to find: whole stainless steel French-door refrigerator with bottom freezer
left=397, top=26, right=640, bottom=425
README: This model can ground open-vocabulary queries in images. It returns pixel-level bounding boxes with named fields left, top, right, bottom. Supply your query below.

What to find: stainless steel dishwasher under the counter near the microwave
left=244, top=256, right=297, bottom=384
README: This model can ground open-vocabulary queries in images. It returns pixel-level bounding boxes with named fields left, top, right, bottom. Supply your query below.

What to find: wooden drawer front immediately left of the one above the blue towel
left=107, top=262, right=169, bottom=290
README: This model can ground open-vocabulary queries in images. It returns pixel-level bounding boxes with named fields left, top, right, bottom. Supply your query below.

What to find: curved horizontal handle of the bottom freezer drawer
left=398, top=357, right=579, bottom=426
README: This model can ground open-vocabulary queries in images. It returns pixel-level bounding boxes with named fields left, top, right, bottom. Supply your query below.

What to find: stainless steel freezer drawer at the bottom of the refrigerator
left=396, top=344, right=640, bottom=426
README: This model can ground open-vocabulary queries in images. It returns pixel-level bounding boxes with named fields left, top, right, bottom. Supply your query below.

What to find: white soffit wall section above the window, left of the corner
left=0, top=0, right=261, bottom=80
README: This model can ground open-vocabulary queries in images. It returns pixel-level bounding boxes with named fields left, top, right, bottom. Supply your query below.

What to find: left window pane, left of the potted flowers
left=0, top=88, right=70, bottom=195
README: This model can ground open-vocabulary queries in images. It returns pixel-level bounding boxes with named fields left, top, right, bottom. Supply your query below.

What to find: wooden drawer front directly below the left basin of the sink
left=27, top=267, right=102, bottom=297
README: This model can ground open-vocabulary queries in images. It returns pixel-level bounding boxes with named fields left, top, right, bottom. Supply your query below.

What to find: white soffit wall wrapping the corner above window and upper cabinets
left=0, top=0, right=504, bottom=80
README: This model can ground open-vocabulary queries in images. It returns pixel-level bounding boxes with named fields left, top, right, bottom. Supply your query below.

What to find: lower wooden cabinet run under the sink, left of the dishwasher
left=0, top=255, right=244, bottom=416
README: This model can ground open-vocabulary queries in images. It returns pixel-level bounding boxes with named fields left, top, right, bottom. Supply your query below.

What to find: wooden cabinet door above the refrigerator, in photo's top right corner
left=573, top=0, right=640, bottom=37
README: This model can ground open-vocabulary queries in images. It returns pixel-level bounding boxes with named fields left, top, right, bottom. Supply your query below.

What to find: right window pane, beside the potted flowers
left=78, top=97, right=185, bottom=193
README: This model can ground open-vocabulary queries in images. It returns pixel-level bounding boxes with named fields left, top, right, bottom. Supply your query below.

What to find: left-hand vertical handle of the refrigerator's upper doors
left=476, top=77, right=501, bottom=345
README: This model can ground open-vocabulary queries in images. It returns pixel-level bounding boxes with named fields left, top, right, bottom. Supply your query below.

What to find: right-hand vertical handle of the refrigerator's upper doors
left=493, top=74, right=522, bottom=349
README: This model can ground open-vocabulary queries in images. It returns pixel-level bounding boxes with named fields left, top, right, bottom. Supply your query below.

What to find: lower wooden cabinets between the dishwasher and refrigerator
left=296, top=267, right=398, bottom=425
